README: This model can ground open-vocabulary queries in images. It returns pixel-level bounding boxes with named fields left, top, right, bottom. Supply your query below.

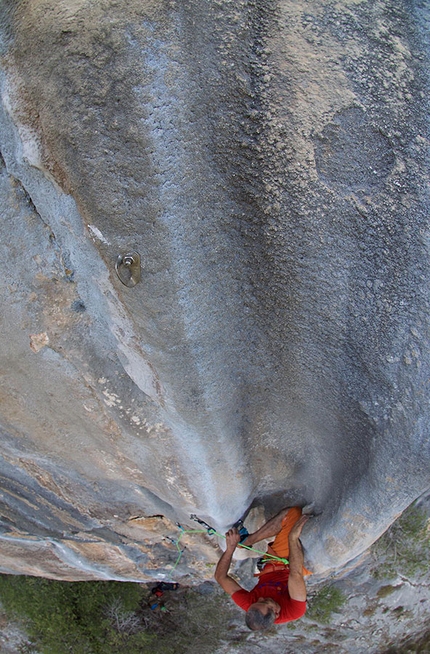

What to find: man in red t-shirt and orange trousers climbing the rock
left=215, top=507, right=310, bottom=631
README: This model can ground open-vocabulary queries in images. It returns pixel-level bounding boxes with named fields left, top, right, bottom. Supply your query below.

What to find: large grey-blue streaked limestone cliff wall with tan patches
left=0, top=0, right=430, bottom=580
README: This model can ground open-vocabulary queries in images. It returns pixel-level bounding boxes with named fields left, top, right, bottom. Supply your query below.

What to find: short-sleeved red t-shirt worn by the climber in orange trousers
left=231, top=568, right=306, bottom=624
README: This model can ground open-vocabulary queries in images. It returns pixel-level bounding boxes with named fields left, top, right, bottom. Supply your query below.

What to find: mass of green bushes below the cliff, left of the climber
left=0, top=575, right=236, bottom=654
